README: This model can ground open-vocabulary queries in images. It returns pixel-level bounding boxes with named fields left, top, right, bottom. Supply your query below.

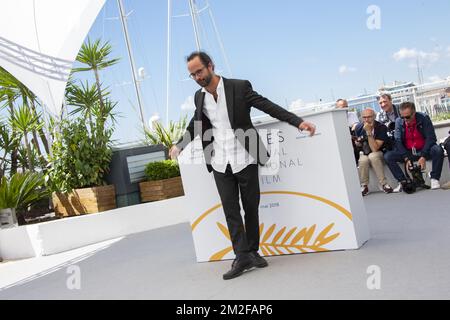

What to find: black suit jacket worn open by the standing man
left=177, top=78, right=303, bottom=172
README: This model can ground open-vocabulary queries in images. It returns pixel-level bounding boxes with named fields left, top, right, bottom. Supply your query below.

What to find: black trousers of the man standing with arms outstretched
left=213, top=164, right=260, bottom=257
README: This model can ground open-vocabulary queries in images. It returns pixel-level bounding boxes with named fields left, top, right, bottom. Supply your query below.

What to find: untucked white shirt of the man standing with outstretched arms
left=202, top=77, right=255, bottom=173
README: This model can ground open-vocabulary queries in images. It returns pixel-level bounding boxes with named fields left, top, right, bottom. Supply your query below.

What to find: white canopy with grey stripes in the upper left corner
left=0, top=0, right=105, bottom=115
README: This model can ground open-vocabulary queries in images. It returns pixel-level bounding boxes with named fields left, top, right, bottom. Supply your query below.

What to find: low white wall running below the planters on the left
left=0, top=196, right=188, bottom=260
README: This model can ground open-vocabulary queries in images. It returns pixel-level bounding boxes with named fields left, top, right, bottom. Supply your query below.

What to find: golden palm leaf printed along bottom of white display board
left=209, top=222, right=340, bottom=261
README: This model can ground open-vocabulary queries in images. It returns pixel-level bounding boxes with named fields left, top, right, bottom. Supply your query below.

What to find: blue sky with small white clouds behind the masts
left=79, top=0, right=450, bottom=142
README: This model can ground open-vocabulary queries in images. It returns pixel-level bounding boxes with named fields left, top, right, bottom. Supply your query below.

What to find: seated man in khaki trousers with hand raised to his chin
left=355, top=108, right=393, bottom=196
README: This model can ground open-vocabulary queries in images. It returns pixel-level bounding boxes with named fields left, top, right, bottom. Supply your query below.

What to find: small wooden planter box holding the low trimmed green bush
left=139, top=177, right=184, bottom=202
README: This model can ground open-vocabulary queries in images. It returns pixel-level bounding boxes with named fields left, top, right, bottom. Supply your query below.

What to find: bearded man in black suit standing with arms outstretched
left=169, top=52, right=315, bottom=280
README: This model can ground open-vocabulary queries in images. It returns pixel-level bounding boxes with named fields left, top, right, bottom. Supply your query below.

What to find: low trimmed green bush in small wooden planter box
left=139, top=160, right=184, bottom=202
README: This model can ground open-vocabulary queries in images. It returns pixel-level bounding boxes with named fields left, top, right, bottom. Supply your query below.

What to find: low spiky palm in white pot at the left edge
left=0, top=171, right=47, bottom=228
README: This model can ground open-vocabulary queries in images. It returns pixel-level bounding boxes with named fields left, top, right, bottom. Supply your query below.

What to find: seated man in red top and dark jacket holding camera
left=384, top=102, right=444, bottom=192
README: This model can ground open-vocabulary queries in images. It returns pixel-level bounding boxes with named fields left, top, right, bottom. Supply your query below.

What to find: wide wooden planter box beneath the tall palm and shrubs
left=52, top=185, right=116, bottom=217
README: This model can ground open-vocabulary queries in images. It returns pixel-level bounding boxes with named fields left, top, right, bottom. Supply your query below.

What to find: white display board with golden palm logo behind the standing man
left=179, top=110, right=369, bottom=262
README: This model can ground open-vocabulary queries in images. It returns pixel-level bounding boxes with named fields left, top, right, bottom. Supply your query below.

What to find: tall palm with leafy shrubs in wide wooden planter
left=49, top=39, right=119, bottom=216
